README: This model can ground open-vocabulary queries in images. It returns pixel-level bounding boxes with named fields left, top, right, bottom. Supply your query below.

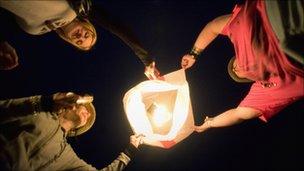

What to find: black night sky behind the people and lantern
left=0, top=0, right=304, bottom=171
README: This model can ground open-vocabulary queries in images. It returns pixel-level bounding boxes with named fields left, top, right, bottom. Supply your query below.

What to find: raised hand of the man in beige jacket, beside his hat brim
left=53, top=92, right=93, bottom=111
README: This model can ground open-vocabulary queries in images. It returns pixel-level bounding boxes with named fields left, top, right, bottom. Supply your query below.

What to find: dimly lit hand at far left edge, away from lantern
left=0, top=41, right=19, bottom=70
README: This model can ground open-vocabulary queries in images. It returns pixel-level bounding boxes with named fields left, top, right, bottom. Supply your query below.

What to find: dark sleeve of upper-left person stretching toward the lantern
left=89, top=5, right=153, bottom=66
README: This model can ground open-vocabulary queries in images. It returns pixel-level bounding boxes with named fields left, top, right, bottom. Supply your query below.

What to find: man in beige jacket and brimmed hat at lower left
left=0, top=92, right=142, bottom=170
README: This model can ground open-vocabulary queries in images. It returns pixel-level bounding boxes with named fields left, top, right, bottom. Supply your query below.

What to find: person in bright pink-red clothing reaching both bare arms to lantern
left=181, top=0, right=304, bottom=132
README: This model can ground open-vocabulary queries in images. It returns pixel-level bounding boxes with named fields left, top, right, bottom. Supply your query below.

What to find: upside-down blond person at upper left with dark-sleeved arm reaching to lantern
left=0, top=0, right=160, bottom=79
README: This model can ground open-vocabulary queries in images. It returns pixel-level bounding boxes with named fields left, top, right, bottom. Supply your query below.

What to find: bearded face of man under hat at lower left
left=61, top=105, right=91, bottom=128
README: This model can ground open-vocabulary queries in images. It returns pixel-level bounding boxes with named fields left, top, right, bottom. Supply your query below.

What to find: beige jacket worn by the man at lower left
left=0, top=96, right=130, bottom=171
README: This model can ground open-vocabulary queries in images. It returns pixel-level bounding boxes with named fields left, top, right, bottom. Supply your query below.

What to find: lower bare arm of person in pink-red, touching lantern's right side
left=195, top=107, right=261, bottom=132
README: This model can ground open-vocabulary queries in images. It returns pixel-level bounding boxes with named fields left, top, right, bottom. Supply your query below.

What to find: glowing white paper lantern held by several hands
left=123, top=69, right=194, bottom=148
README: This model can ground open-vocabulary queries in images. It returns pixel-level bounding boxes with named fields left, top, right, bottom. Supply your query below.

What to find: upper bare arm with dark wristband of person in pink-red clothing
left=181, top=14, right=231, bottom=69
